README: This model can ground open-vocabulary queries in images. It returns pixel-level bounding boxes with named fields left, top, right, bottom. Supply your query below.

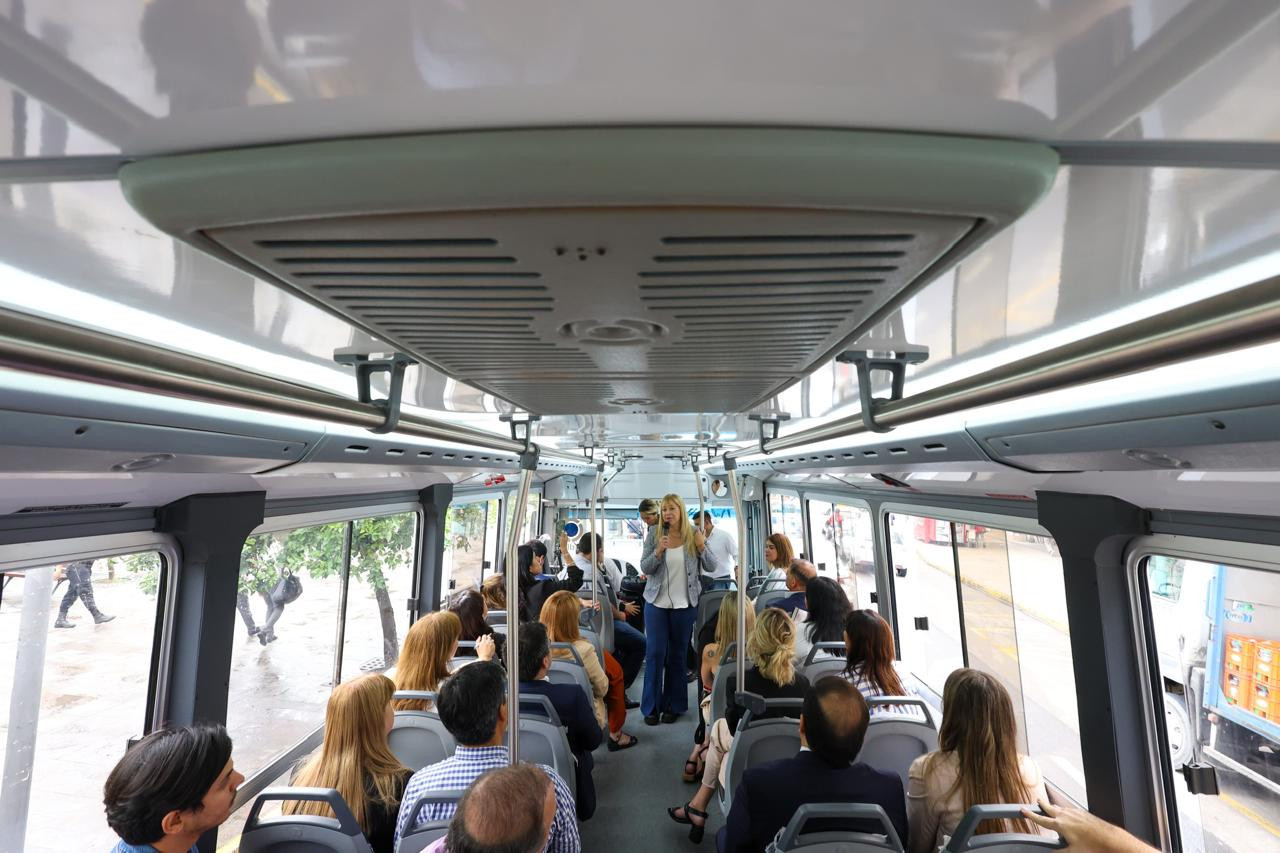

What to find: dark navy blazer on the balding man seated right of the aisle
left=716, top=751, right=910, bottom=853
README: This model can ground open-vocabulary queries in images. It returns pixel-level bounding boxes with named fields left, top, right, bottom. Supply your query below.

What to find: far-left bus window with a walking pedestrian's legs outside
left=0, top=552, right=165, bottom=850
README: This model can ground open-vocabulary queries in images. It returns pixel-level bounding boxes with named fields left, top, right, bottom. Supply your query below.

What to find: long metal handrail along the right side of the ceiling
left=726, top=275, right=1280, bottom=461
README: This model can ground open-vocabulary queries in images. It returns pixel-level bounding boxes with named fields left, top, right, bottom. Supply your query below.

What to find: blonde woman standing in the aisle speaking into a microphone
left=640, top=494, right=719, bottom=726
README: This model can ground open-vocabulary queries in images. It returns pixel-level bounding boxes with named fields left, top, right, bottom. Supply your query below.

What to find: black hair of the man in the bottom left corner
left=102, top=724, right=232, bottom=844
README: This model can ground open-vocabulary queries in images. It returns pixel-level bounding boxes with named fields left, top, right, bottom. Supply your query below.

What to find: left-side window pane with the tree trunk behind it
left=342, top=512, right=417, bottom=680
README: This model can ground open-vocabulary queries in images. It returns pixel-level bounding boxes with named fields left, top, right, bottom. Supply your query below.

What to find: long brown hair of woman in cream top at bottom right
left=924, top=667, right=1036, bottom=834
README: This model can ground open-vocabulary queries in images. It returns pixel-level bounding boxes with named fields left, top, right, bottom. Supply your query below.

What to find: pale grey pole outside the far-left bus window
left=0, top=566, right=55, bottom=850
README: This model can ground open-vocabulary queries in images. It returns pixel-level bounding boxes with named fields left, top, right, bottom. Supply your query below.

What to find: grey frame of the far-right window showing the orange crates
left=1124, top=533, right=1280, bottom=849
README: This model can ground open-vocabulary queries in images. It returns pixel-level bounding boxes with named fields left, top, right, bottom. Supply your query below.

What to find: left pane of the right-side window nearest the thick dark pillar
left=888, top=514, right=964, bottom=697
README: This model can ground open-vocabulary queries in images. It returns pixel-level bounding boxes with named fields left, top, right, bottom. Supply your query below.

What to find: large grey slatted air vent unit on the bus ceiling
left=120, top=128, right=1057, bottom=414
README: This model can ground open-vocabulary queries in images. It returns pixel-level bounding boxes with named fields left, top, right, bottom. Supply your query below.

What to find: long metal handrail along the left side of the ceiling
left=0, top=311, right=582, bottom=462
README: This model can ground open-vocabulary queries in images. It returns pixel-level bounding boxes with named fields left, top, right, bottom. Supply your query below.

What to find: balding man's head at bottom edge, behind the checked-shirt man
left=426, top=763, right=556, bottom=853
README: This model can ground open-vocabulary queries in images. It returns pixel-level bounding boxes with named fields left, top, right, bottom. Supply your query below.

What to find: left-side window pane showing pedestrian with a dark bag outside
left=227, top=523, right=347, bottom=776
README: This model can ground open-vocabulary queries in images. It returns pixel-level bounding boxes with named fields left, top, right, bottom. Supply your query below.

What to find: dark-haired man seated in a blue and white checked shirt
left=396, top=661, right=585, bottom=853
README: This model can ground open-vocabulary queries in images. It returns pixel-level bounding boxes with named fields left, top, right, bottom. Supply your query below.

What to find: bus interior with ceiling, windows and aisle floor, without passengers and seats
left=0, top=0, right=1280, bottom=853
